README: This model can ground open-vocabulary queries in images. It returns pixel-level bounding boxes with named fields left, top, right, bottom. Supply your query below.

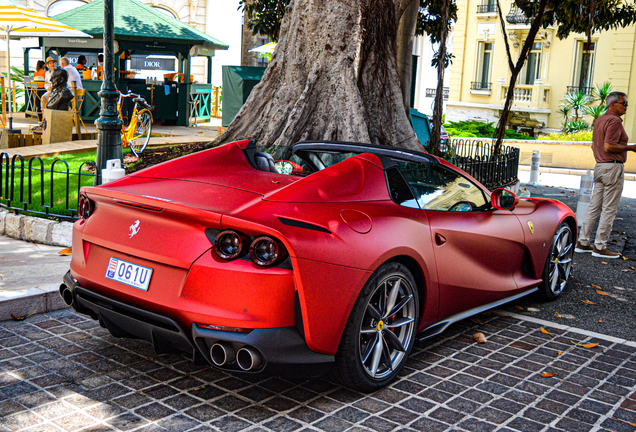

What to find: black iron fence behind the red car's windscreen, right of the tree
left=449, top=139, right=520, bottom=190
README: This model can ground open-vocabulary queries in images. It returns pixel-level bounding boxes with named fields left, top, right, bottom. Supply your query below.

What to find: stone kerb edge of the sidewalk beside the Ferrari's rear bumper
left=0, top=284, right=69, bottom=321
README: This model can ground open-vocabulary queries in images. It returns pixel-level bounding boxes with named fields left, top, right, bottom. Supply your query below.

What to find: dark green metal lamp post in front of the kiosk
left=95, top=0, right=124, bottom=184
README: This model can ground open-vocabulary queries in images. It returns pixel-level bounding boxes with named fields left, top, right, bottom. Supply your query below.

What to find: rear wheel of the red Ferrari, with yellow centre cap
left=335, top=263, right=419, bottom=392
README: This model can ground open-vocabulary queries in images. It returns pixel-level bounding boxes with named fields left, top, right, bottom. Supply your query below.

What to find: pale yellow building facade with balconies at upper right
left=446, top=0, right=636, bottom=140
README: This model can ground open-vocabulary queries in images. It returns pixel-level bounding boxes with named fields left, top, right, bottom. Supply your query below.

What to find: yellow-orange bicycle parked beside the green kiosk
left=117, top=91, right=155, bottom=156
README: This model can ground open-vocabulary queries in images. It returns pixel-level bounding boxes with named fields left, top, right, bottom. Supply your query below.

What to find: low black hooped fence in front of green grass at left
left=0, top=153, right=95, bottom=219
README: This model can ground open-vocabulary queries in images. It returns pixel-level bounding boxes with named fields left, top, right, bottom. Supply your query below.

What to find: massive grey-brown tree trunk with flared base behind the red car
left=211, top=0, right=422, bottom=154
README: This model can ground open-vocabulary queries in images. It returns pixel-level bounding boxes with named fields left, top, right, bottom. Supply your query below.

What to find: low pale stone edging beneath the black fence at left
left=0, top=209, right=73, bottom=247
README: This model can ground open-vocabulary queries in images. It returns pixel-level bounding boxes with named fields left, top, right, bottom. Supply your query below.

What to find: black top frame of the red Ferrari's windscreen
left=292, top=141, right=439, bottom=168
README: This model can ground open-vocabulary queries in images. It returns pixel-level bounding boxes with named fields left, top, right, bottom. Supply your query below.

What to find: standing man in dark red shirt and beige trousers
left=575, top=92, right=636, bottom=259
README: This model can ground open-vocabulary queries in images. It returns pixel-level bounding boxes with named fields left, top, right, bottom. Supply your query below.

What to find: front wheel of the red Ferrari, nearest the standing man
left=539, top=222, right=574, bottom=301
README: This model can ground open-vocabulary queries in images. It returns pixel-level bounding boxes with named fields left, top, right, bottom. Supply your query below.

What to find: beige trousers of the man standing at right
left=579, top=163, right=625, bottom=250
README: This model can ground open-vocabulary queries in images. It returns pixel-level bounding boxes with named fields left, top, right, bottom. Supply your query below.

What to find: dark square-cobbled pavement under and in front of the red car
left=0, top=310, right=636, bottom=432
